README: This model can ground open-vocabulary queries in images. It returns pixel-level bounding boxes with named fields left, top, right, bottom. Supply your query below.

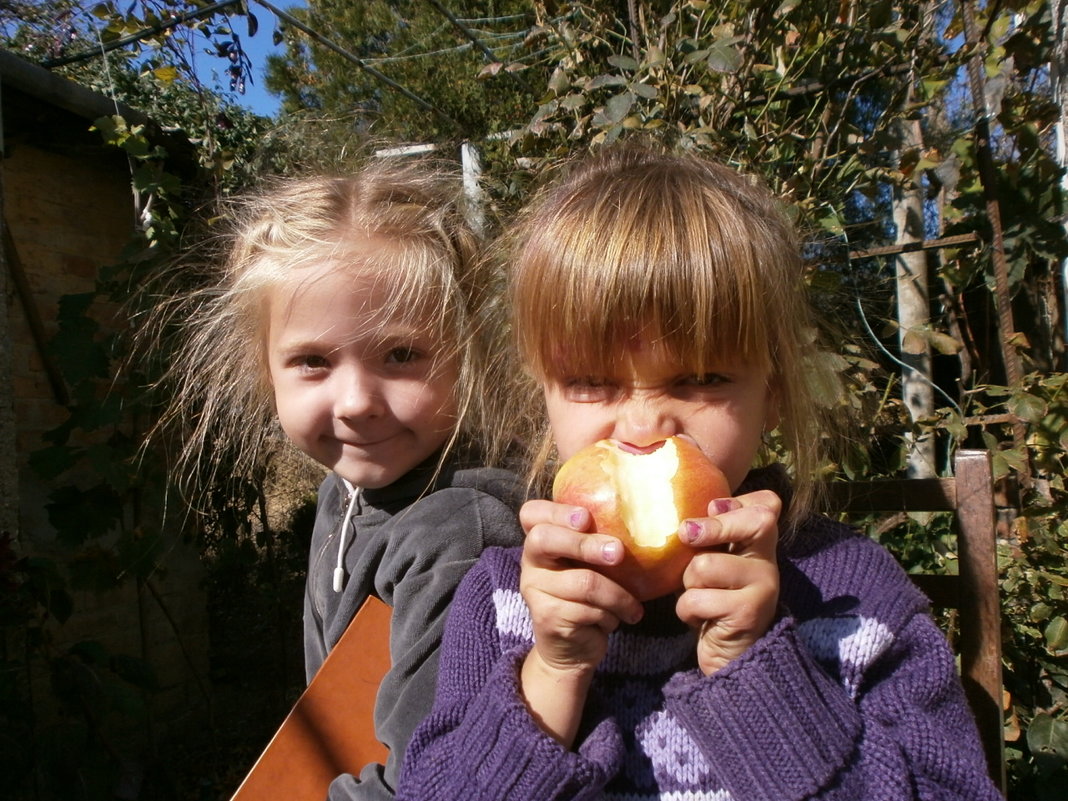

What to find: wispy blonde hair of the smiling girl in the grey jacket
left=155, top=159, right=507, bottom=495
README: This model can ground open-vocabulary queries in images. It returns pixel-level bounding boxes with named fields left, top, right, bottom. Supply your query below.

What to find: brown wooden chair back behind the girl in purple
left=823, top=451, right=1008, bottom=795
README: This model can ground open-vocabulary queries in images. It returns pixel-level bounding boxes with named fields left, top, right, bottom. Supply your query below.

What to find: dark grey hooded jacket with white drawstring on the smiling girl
left=304, top=455, right=522, bottom=801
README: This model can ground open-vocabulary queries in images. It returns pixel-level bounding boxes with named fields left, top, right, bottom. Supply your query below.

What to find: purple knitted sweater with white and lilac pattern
left=397, top=471, right=1001, bottom=801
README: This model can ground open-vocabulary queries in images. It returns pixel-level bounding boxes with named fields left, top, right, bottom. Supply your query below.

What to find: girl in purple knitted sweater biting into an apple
left=397, top=145, right=1000, bottom=801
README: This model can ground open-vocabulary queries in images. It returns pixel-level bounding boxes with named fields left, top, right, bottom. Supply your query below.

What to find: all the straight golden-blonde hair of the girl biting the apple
left=508, top=143, right=821, bottom=520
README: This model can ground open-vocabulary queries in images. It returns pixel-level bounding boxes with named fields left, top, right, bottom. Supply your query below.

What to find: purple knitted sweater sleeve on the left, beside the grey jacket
left=397, top=553, right=623, bottom=801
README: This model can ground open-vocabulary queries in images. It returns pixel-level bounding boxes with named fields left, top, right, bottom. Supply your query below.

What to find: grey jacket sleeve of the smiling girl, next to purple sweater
left=329, top=488, right=522, bottom=801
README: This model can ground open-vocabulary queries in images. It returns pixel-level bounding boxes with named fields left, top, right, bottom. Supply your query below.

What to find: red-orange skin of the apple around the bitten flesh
left=552, top=437, right=731, bottom=602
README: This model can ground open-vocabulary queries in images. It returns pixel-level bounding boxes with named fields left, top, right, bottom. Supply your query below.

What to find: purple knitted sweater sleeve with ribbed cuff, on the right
left=666, top=612, right=1001, bottom=801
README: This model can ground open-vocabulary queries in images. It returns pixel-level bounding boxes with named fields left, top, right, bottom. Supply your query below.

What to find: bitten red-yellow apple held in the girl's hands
left=552, top=437, right=731, bottom=601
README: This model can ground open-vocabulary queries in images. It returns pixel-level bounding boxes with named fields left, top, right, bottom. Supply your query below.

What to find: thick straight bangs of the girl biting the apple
left=513, top=164, right=800, bottom=378
